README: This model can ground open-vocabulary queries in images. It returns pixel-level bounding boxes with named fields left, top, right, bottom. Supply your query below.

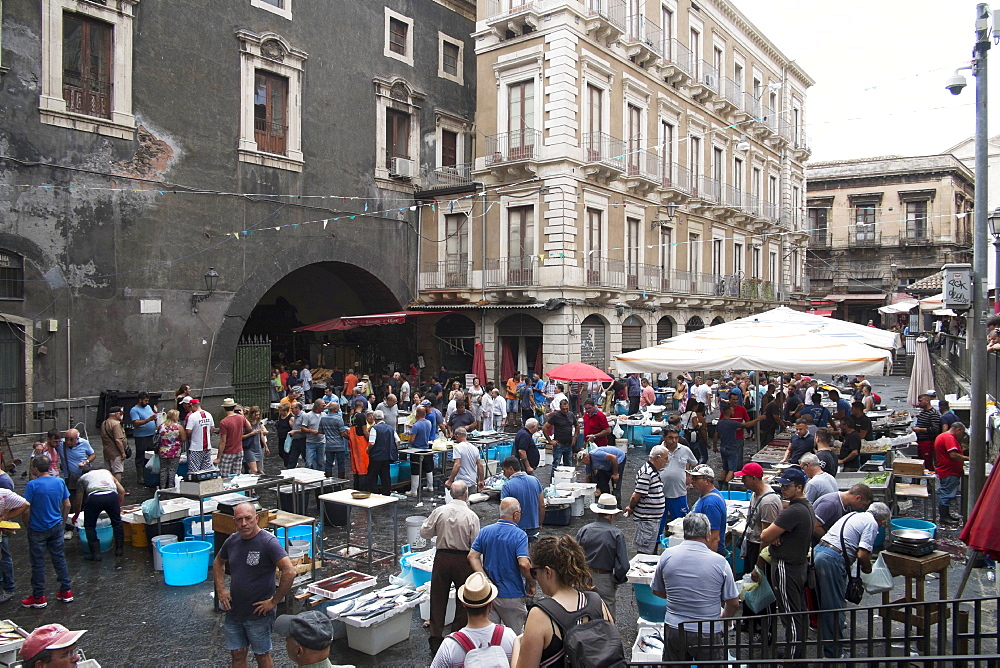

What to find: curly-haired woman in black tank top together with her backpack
left=511, top=535, right=625, bottom=668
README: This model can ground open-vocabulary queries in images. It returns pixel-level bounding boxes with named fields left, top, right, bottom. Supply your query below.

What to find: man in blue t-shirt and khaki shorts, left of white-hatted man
left=469, top=497, right=535, bottom=635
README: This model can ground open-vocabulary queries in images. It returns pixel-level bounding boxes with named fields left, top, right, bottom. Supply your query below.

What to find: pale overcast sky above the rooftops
left=733, top=0, right=1000, bottom=162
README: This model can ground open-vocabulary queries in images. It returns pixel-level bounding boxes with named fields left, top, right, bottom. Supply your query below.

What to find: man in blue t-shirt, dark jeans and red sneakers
left=21, top=456, right=73, bottom=608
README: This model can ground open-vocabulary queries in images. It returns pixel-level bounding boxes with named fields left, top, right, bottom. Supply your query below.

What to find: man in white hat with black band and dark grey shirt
left=576, top=494, right=628, bottom=618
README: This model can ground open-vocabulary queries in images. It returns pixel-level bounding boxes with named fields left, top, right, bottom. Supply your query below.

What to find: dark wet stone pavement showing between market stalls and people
left=0, top=377, right=997, bottom=667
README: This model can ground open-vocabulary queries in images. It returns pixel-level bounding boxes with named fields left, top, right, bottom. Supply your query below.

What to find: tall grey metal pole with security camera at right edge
left=965, top=3, right=990, bottom=516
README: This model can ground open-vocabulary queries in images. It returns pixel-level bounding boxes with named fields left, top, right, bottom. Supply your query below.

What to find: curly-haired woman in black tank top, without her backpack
left=511, top=535, right=614, bottom=668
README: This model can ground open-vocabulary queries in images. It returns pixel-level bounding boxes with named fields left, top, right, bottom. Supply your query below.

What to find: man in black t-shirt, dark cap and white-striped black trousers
left=752, top=468, right=816, bottom=659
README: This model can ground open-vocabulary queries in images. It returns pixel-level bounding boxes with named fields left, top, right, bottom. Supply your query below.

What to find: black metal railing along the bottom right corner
left=629, top=596, right=1000, bottom=668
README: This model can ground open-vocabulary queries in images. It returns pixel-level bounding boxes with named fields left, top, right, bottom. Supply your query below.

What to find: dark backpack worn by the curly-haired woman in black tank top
left=536, top=591, right=628, bottom=668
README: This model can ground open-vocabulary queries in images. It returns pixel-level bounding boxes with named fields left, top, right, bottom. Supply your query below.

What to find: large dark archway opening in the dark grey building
left=233, top=262, right=404, bottom=396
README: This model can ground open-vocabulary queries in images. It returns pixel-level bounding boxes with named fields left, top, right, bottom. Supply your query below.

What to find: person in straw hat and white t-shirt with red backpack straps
left=431, top=572, right=516, bottom=668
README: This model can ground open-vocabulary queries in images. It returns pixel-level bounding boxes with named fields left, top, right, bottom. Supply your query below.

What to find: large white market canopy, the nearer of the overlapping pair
left=616, top=318, right=892, bottom=376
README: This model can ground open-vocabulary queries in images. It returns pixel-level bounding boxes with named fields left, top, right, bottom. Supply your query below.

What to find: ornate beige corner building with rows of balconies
left=417, top=0, right=813, bottom=378
